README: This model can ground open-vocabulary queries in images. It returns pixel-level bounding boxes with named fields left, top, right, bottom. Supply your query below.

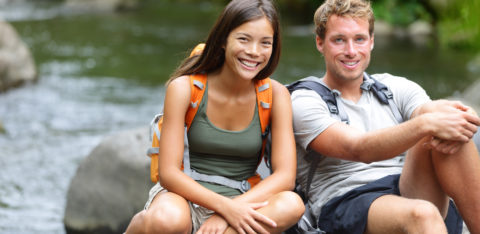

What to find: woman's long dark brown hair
left=167, top=0, right=281, bottom=83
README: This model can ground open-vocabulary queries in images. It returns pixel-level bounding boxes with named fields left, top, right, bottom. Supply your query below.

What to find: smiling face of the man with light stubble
left=316, top=15, right=373, bottom=82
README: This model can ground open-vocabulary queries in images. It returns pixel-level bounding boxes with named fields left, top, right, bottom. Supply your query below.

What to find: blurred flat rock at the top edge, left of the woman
left=66, top=0, right=139, bottom=11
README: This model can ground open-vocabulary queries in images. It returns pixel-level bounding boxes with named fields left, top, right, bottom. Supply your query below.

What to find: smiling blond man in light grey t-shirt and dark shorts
left=292, top=0, right=480, bottom=234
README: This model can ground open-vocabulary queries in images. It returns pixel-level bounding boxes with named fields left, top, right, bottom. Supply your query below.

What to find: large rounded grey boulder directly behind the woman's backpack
left=64, top=127, right=153, bottom=233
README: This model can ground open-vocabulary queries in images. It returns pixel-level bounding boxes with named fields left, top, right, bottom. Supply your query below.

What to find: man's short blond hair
left=313, top=0, right=375, bottom=39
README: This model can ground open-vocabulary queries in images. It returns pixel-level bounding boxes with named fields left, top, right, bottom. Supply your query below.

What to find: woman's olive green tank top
left=188, top=82, right=262, bottom=196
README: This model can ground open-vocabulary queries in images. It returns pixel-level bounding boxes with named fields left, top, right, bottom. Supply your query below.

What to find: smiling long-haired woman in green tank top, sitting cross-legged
left=127, top=0, right=304, bottom=233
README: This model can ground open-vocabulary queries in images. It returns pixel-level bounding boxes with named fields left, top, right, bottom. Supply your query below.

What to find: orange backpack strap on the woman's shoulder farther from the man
left=185, top=74, right=207, bottom=130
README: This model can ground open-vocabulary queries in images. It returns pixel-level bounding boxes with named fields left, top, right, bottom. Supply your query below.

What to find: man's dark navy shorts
left=318, top=174, right=463, bottom=234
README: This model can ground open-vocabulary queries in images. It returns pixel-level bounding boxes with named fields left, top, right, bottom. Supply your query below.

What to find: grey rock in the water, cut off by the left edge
left=0, top=21, right=37, bottom=92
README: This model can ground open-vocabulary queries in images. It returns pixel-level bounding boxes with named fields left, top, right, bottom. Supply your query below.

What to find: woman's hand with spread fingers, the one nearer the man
left=222, top=200, right=277, bottom=234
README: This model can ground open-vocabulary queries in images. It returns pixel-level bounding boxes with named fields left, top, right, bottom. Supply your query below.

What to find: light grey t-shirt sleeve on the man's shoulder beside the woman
left=292, top=90, right=340, bottom=150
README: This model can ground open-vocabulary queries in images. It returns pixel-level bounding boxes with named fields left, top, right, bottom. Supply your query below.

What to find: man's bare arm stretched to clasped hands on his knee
left=309, top=100, right=480, bottom=163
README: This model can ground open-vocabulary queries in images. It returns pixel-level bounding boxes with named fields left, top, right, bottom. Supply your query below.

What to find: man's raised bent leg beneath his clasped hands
left=400, top=139, right=480, bottom=233
